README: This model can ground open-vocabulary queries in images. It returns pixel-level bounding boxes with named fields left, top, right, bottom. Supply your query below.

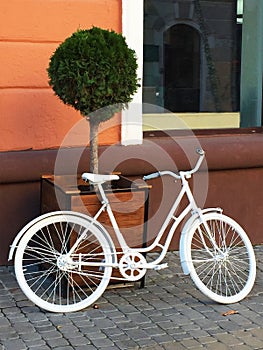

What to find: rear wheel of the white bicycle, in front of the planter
left=15, top=212, right=112, bottom=312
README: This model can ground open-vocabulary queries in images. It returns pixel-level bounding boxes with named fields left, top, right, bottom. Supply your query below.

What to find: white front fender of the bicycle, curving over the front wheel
left=179, top=208, right=222, bottom=275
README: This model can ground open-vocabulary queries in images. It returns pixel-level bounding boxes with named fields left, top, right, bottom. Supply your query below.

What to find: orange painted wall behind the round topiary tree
left=0, top=0, right=121, bottom=151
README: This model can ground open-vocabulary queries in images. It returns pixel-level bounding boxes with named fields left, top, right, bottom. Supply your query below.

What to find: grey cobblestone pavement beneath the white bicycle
left=0, top=246, right=263, bottom=350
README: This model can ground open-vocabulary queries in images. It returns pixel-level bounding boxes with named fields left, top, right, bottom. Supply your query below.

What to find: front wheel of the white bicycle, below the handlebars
left=186, top=213, right=256, bottom=304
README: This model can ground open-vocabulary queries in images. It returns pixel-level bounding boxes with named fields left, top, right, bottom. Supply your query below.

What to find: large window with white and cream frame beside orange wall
left=122, top=0, right=263, bottom=142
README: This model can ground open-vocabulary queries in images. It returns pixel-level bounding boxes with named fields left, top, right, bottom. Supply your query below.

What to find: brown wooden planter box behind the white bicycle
left=41, top=175, right=150, bottom=286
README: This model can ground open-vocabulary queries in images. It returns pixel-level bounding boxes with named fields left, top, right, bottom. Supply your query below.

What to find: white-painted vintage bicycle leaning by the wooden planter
left=9, top=149, right=256, bottom=312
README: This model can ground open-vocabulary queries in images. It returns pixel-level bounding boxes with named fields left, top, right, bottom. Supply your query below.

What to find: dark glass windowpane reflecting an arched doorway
left=143, top=0, right=243, bottom=123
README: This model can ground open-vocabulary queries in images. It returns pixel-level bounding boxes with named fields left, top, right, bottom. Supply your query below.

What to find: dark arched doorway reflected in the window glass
left=164, top=24, right=200, bottom=112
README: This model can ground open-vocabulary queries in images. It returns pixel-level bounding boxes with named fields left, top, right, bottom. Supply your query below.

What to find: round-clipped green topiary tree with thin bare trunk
left=47, top=27, right=139, bottom=173
